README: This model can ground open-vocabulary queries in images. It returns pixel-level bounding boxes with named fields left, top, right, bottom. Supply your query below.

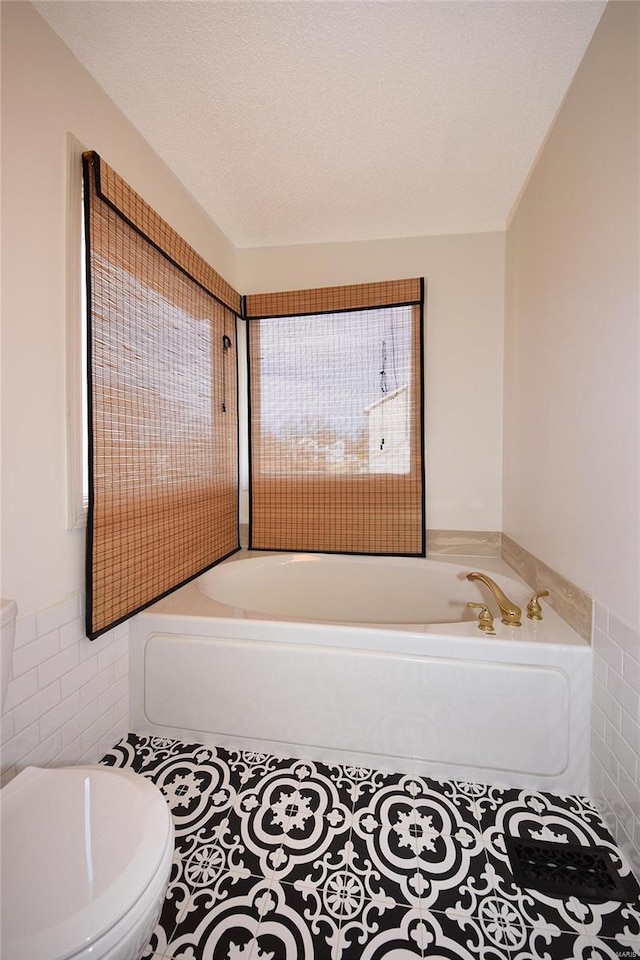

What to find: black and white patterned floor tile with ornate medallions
left=102, top=734, right=640, bottom=960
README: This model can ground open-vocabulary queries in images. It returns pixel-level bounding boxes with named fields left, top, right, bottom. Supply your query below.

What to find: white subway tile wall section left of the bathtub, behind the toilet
left=0, top=594, right=129, bottom=784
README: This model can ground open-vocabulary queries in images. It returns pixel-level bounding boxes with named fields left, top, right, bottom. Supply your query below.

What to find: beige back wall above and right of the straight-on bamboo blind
left=236, top=233, right=504, bottom=530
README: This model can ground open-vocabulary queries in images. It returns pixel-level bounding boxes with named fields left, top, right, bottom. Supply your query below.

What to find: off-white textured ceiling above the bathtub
left=36, top=0, right=605, bottom=247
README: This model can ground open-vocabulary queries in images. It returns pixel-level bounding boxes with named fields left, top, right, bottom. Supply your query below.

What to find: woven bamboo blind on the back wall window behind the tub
left=245, top=279, right=425, bottom=556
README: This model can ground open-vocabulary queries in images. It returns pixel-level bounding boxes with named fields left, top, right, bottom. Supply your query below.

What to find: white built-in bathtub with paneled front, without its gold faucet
left=130, top=554, right=592, bottom=793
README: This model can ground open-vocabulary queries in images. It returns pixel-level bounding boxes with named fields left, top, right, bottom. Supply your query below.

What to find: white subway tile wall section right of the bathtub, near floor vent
left=591, top=601, right=640, bottom=877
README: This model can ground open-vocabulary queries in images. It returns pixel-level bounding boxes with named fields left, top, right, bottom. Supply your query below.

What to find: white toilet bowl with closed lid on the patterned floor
left=0, top=766, right=173, bottom=960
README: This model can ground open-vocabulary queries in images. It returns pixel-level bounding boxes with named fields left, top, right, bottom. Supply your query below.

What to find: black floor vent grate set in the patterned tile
left=505, top=836, right=638, bottom=902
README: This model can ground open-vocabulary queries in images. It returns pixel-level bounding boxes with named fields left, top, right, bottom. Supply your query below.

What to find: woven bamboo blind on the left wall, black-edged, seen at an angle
left=83, top=153, right=240, bottom=638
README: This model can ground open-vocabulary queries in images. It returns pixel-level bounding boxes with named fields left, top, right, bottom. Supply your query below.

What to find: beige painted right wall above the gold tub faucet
left=503, top=3, right=640, bottom=630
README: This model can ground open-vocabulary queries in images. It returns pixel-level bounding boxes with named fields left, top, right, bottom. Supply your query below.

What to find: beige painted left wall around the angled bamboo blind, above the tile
left=1, top=2, right=234, bottom=616
